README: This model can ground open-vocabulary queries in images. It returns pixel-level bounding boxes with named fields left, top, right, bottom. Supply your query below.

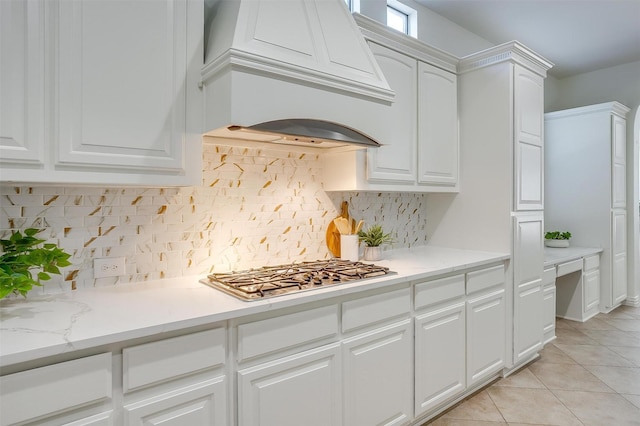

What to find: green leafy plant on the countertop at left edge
left=0, top=228, right=71, bottom=299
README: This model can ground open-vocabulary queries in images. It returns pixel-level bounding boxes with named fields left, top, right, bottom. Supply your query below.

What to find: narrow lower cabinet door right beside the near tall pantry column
left=467, top=289, right=506, bottom=387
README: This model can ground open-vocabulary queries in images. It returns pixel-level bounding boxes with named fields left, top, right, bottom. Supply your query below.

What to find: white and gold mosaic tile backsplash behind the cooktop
left=0, top=143, right=427, bottom=293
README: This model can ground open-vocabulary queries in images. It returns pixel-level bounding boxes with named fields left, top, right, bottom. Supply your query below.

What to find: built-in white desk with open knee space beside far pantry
left=543, top=247, right=602, bottom=330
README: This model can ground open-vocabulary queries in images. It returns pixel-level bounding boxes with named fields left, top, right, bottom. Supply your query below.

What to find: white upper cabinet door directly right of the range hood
left=367, top=43, right=418, bottom=183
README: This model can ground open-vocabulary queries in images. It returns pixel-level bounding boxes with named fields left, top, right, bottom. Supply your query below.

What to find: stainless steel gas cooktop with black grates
left=201, top=259, right=393, bottom=300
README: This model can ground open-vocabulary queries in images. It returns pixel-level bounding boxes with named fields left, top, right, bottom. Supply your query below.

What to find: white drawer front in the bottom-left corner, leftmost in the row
left=0, top=352, right=112, bottom=426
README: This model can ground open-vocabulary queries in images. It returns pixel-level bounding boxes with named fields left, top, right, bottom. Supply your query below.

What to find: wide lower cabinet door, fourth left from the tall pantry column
left=238, top=343, right=342, bottom=426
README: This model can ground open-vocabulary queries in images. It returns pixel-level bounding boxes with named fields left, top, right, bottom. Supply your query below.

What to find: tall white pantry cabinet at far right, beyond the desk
left=545, top=102, right=629, bottom=312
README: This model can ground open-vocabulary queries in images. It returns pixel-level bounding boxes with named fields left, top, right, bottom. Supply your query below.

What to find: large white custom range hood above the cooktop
left=202, top=0, right=394, bottom=148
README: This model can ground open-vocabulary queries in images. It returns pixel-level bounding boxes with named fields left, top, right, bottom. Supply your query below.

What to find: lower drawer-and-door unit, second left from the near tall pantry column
left=414, top=274, right=466, bottom=416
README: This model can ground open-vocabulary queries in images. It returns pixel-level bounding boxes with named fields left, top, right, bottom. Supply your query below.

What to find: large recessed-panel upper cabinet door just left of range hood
left=54, top=0, right=188, bottom=172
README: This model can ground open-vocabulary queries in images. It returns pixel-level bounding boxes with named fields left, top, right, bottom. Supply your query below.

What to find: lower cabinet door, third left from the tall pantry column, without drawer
left=342, top=320, right=413, bottom=425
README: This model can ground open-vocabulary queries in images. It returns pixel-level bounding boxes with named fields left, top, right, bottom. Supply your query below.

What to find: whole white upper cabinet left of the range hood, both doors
left=0, top=0, right=203, bottom=185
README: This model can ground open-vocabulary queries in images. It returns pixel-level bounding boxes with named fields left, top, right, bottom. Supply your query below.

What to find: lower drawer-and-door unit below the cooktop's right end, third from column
left=342, top=288, right=413, bottom=425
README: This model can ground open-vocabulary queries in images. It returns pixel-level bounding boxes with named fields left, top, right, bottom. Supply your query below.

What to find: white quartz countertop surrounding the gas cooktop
left=0, top=246, right=510, bottom=367
